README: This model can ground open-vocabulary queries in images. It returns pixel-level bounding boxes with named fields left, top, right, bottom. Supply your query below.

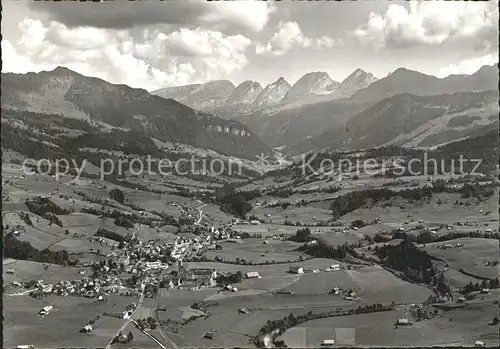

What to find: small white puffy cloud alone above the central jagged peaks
left=255, top=21, right=342, bottom=56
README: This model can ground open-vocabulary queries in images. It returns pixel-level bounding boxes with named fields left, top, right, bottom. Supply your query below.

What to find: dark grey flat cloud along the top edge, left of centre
left=29, top=0, right=275, bottom=31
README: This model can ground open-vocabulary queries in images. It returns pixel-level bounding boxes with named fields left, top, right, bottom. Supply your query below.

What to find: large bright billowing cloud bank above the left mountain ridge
left=2, top=18, right=252, bottom=90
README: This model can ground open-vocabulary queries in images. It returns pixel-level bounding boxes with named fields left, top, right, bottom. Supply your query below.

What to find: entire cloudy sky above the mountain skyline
left=2, top=0, right=498, bottom=91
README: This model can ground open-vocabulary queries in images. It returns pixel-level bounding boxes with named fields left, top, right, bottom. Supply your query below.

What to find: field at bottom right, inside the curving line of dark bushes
left=281, top=290, right=498, bottom=348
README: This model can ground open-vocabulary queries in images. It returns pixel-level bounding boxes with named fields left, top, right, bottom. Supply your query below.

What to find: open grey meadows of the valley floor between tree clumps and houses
left=2, top=131, right=499, bottom=349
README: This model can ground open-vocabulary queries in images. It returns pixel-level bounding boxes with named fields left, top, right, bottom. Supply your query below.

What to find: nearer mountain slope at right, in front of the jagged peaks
left=290, top=89, right=500, bottom=154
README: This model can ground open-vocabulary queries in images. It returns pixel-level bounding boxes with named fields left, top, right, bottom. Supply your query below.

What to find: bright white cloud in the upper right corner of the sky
left=351, top=1, right=498, bottom=49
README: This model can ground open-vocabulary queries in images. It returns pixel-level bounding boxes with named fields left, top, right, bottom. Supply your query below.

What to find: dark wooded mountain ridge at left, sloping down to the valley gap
left=1, top=67, right=271, bottom=159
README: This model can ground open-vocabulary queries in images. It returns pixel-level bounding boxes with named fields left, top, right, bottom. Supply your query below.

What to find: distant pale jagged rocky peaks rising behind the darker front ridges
left=148, top=66, right=498, bottom=151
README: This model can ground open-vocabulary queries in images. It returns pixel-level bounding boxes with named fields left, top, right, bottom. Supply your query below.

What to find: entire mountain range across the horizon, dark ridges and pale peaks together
left=1, top=66, right=499, bottom=159
